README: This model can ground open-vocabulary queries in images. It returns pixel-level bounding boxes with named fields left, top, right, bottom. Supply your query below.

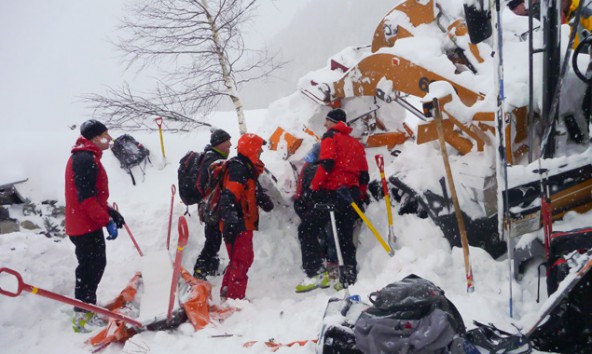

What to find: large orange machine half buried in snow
left=270, top=0, right=592, bottom=352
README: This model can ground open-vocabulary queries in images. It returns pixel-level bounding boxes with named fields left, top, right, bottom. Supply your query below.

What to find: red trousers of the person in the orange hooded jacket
left=220, top=230, right=254, bottom=299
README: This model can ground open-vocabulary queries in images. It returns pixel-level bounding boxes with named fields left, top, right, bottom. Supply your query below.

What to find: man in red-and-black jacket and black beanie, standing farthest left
left=65, top=119, right=125, bottom=332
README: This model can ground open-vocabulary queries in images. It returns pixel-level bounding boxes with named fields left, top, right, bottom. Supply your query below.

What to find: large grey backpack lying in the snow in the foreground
left=354, top=274, right=465, bottom=354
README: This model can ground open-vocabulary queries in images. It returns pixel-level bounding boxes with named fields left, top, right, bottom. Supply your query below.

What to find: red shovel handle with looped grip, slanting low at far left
left=0, top=267, right=144, bottom=328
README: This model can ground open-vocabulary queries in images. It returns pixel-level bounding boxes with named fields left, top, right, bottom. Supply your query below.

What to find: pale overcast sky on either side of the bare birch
left=0, top=0, right=395, bottom=131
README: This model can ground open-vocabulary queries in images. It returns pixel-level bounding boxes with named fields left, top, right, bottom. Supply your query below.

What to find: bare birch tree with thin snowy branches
left=84, top=0, right=281, bottom=134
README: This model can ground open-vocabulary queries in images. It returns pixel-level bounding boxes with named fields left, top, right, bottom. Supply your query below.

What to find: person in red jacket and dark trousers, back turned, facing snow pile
left=296, top=108, right=370, bottom=292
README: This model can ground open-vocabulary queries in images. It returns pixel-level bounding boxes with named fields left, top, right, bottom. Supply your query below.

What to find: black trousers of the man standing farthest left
left=70, top=228, right=107, bottom=311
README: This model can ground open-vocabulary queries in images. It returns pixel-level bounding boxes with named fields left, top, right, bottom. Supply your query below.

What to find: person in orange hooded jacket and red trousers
left=219, top=133, right=273, bottom=301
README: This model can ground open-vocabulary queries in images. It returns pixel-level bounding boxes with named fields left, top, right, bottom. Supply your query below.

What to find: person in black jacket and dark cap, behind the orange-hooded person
left=193, top=129, right=232, bottom=280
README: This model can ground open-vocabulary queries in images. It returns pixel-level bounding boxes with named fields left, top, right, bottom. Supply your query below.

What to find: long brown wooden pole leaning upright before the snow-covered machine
left=431, top=98, right=475, bottom=293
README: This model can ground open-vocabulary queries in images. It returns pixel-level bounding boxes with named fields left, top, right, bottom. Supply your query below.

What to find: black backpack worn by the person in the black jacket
left=177, top=151, right=205, bottom=205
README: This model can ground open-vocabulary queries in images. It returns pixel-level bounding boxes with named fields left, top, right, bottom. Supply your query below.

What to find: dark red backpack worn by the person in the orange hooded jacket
left=199, top=160, right=230, bottom=224
